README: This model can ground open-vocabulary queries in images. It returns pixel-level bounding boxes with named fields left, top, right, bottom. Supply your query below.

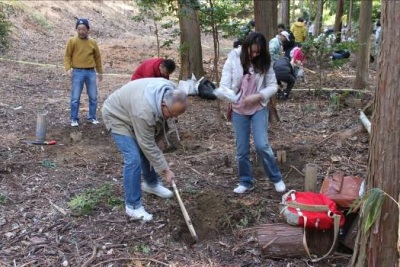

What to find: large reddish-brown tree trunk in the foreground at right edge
left=351, top=0, right=400, bottom=267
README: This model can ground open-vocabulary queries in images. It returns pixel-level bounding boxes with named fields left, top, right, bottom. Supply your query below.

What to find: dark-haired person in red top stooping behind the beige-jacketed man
left=131, top=58, right=176, bottom=81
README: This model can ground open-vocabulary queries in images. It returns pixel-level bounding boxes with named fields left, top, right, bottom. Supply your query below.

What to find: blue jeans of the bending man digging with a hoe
left=111, top=133, right=161, bottom=209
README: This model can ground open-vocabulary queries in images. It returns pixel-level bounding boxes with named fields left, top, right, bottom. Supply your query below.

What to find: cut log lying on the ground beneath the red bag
left=257, top=223, right=334, bottom=258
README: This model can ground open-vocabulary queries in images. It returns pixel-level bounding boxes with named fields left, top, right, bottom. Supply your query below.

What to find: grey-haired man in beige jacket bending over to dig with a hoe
left=102, top=78, right=188, bottom=221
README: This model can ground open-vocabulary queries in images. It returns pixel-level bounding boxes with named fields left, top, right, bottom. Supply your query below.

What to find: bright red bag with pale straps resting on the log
left=279, top=190, right=344, bottom=262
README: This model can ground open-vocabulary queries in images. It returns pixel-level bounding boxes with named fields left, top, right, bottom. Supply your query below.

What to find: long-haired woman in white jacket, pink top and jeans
left=220, top=32, right=286, bottom=194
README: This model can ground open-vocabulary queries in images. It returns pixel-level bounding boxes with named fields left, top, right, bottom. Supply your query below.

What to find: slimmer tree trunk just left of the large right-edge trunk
left=353, top=1, right=374, bottom=89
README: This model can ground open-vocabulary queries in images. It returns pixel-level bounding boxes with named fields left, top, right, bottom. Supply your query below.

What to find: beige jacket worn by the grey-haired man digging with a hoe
left=102, top=78, right=175, bottom=173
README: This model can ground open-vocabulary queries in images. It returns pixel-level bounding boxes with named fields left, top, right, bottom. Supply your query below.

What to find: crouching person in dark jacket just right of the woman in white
left=273, top=57, right=296, bottom=100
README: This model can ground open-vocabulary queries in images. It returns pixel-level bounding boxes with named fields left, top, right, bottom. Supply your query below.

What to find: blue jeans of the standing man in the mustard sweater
left=70, top=69, right=97, bottom=121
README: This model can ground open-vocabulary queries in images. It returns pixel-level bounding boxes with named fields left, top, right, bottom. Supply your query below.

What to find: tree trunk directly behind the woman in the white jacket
left=254, top=0, right=279, bottom=124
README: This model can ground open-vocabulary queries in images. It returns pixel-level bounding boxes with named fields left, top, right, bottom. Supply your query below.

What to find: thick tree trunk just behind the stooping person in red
left=179, top=0, right=204, bottom=80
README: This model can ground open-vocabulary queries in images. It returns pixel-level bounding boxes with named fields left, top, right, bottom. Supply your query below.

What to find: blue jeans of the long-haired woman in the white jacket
left=232, top=108, right=282, bottom=187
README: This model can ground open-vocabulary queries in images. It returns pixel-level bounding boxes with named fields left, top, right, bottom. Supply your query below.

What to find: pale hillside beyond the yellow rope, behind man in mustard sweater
left=4, top=1, right=181, bottom=74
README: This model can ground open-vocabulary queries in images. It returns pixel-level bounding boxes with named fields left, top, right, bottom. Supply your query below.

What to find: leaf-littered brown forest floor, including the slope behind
left=0, top=1, right=375, bottom=267
